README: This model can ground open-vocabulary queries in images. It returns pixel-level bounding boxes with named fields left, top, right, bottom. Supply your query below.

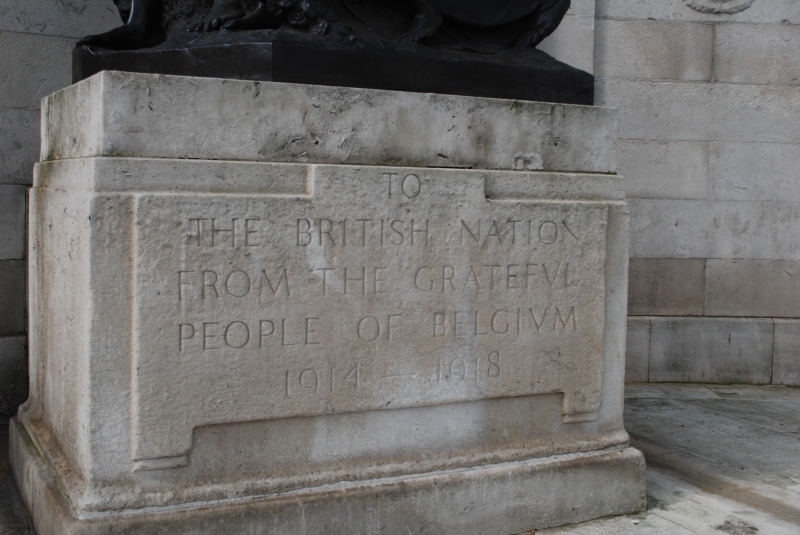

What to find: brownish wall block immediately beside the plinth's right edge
left=628, top=258, right=706, bottom=316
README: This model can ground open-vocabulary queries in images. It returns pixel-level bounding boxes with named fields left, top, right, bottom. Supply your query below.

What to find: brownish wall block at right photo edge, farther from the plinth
left=705, top=259, right=800, bottom=318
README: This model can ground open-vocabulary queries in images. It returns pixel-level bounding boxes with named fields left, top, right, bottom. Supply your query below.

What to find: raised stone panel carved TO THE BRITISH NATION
left=132, top=166, right=608, bottom=460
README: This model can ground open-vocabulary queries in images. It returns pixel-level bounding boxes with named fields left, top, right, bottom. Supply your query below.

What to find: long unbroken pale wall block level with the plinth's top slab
left=595, top=80, right=800, bottom=143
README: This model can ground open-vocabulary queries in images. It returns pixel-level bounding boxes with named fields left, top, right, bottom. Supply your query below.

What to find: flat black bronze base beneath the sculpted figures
left=72, top=39, right=594, bottom=105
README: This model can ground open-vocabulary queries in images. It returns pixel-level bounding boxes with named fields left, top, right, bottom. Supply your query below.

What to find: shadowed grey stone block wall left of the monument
left=0, top=0, right=119, bottom=418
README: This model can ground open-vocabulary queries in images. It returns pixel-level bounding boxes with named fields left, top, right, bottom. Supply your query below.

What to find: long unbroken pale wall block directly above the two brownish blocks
left=628, top=199, right=800, bottom=260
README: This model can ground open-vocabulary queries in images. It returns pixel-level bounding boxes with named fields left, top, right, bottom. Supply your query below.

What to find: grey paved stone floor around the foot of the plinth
left=0, top=385, right=800, bottom=535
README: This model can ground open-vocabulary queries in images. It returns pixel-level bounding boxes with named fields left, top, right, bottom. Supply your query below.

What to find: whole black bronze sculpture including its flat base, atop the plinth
left=73, top=0, right=594, bottom=105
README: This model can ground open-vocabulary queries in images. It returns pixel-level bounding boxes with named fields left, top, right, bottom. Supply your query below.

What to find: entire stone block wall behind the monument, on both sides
left=0, top=0, right=800, bottom=416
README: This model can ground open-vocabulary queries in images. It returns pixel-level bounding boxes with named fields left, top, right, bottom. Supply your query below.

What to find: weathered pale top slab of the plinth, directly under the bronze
left=41, top=72, right=616, bottom=173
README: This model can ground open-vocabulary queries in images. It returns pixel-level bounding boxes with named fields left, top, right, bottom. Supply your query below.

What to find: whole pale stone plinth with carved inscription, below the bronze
left=11, top=72, right=644, bottom=535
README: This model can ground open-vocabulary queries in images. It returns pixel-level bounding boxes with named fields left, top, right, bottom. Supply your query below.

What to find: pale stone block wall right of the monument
left=595, top=0, right=800, bottom=385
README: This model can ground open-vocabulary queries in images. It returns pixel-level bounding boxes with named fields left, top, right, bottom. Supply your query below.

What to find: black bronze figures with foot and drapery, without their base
left=78, top=0, right=570, bottom=52
